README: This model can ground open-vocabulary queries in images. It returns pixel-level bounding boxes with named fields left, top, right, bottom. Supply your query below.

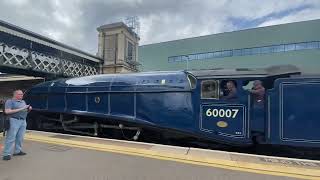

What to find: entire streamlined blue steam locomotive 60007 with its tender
left=26, top=65, right=320, bottom=147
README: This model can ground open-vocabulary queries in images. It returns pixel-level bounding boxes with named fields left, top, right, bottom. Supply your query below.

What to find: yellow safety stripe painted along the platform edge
left=25, top=133, right=320, bottom=180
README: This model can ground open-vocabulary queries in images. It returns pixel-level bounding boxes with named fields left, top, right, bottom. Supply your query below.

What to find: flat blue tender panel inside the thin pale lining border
left=280, top=81, right=320, bottom=143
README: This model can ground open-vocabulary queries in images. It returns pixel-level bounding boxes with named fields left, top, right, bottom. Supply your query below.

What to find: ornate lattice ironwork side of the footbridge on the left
left=0, top=42, right=99, bottom=77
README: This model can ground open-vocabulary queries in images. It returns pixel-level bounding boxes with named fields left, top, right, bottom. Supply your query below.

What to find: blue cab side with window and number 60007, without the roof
left=199, top=77, right=258, bottom=144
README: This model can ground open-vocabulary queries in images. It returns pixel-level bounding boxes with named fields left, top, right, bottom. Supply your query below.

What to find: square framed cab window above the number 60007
left=201, top=80, right=219, bottom=99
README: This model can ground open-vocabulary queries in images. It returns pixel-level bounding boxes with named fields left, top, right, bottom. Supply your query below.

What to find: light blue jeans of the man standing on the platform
left=3, top=118, right=27, bottom=156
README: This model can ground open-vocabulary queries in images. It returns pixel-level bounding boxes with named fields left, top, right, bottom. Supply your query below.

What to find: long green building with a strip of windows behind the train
left=139, top=20, right=320, bottom=74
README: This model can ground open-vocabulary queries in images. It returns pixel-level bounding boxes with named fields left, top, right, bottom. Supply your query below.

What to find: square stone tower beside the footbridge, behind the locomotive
left=97, top=22, right=140, bottom=74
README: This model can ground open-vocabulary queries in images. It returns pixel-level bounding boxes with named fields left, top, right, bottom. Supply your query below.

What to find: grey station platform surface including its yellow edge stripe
left=0, top=131, right=320, bottom=180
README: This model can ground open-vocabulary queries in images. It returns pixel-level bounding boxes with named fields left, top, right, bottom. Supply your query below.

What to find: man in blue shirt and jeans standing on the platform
left=2, top=90, right=32, bottom=161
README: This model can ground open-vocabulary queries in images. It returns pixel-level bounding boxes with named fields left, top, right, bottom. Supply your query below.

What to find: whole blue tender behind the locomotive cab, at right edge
left=267, top=77, right=320, bottom=147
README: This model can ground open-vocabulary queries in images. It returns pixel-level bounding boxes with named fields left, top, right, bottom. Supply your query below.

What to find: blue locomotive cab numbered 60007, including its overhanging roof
left=186, top=66, right=298, bottom=145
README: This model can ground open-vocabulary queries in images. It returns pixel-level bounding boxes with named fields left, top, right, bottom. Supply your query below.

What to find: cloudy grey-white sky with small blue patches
left=0, top=0, right=320, bottom=54
